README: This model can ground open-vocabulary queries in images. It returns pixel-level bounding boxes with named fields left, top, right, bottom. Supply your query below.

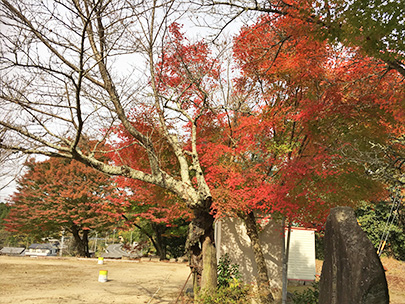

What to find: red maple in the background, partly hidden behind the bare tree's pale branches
left=110, top=106, right=191, bottom=259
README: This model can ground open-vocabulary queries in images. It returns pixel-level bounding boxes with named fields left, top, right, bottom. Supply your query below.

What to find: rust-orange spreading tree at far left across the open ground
left=5, top=158, right=124, bottom=256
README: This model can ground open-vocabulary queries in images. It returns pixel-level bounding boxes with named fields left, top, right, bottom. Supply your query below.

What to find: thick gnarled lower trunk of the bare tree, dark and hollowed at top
left=186, top=201, right=217, bottom=297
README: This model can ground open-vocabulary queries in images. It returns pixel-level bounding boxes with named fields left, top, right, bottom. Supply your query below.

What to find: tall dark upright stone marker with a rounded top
left=319, top=207, right=389, bottom=304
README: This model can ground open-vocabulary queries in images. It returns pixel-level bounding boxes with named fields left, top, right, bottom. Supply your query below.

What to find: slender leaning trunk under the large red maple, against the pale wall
left=243, top=212, right=274, bottom=304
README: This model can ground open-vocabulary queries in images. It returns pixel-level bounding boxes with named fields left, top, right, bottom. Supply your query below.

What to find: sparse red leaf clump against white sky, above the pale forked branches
left=155, top=23, right=220, bottom=113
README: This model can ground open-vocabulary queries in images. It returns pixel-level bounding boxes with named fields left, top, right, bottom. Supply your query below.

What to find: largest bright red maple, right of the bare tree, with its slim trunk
left=199, top=15, right=404, bottom=302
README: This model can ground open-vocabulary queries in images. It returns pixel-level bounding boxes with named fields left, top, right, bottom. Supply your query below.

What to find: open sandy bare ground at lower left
left=0, top=256, right=190, bottom=304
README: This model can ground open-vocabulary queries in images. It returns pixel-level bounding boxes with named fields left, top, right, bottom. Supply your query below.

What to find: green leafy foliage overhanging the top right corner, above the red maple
left=317, top=0, right=405, bottom=60
